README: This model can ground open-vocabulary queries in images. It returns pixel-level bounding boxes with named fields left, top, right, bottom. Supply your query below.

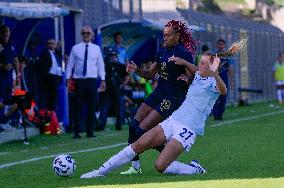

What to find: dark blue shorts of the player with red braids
left=145, top=91, right=185, bottom=119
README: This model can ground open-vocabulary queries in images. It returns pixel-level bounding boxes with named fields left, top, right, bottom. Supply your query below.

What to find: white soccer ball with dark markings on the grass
left=52, top=155, right=76, bottom=177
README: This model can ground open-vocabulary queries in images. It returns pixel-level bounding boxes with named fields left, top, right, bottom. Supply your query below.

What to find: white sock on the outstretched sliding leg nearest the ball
left=99, top=145, right=136, bottom=175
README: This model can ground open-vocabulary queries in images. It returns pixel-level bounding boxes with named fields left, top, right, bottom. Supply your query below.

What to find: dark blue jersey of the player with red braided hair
left=156, top=45, right=194, bottom=95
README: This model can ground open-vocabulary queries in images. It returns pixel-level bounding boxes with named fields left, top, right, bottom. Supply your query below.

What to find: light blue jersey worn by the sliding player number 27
left=171, top=71, right=219, bottom=135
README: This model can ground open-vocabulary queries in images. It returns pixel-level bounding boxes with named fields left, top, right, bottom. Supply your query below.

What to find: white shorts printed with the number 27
left=160, top=117, right=196, bottom=151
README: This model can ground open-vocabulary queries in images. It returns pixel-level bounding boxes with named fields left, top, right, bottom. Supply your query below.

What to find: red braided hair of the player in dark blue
left=165, top=20, right=198, bottom=55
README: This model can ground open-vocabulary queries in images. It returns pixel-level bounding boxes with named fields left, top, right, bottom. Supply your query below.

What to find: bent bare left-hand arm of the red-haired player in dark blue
left=126, top=61, right=159, bottom=80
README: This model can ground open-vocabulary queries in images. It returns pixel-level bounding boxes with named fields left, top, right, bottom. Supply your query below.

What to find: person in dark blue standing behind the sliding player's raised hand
left=212, top=39, right=234, bottom=120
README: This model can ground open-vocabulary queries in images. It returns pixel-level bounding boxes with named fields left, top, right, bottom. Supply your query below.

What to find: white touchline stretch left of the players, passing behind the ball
left=0, top=142, right=127, bottom=169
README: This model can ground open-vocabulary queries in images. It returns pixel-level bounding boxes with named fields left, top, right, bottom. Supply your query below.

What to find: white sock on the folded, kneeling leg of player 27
left=163, top=161, right=196, bottom=174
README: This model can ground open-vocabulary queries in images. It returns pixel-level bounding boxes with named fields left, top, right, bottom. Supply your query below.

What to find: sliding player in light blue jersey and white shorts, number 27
left=81, top=54, right=227, bottom=178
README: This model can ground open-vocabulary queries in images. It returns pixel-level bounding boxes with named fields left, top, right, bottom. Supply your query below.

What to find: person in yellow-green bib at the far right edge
left=273, top=53, right=284, bottom=104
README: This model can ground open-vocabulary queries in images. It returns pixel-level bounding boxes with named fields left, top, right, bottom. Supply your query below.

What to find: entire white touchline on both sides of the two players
left=0, top=110, right=284, bottom=169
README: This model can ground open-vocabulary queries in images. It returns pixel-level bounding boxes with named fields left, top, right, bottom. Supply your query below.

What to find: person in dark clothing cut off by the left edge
left=0, top=26, right=19, bottom=128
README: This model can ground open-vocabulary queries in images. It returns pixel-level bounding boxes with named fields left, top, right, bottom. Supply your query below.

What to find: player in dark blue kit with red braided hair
left=121, top=20, right=196, bottom=174
